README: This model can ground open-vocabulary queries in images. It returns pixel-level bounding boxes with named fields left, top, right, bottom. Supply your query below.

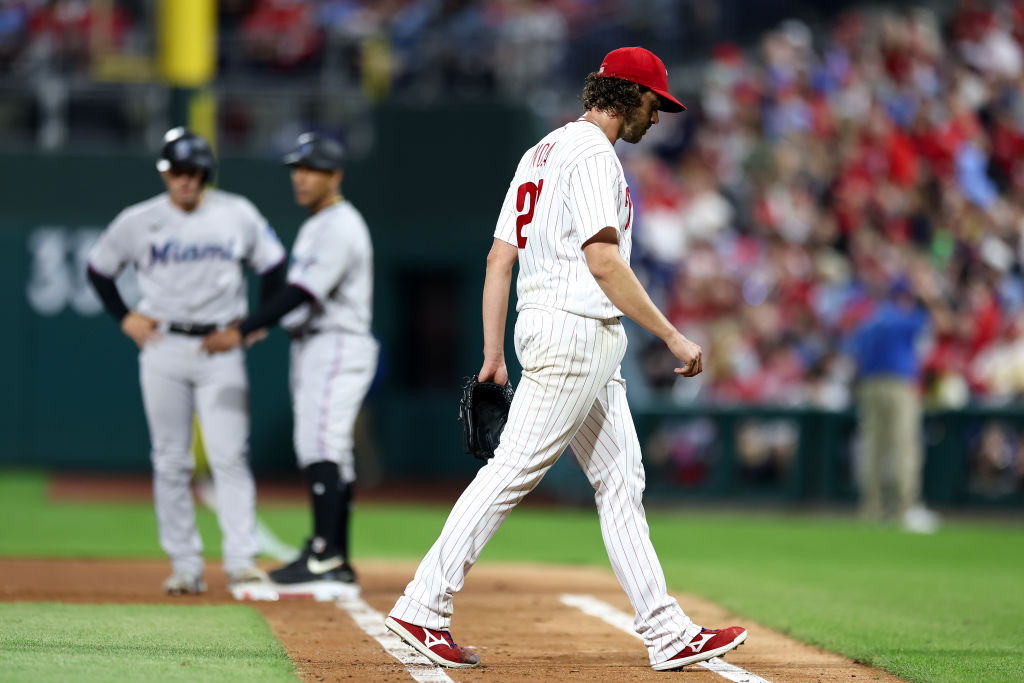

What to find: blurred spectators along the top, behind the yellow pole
left=0, top=0, right=622, bottom=94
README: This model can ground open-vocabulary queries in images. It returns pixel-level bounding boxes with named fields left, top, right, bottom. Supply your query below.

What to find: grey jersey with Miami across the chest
left=89, top=188, right=286, bottom=325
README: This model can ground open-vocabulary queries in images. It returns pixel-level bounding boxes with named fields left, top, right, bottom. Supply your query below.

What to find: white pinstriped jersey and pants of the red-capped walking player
left=391, top=119, right=700, bottom=664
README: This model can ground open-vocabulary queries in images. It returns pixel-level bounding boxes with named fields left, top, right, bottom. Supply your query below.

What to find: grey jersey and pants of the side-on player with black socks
left=281, top=200, right=378, bottom=483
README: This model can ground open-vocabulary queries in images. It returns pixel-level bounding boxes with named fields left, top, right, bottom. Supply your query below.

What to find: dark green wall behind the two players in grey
left=0, top=106, right=534, bottom=477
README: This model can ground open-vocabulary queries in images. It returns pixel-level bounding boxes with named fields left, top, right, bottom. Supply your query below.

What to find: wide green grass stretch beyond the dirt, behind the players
left=0, top=473, right=1024, bottom=681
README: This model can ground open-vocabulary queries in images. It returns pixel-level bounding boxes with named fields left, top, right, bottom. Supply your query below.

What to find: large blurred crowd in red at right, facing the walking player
left=626, top=1, right=1024, bottom=410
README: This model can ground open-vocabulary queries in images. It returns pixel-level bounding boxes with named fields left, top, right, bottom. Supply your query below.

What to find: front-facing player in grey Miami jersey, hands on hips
left=89, top=128, right=286, bottom=595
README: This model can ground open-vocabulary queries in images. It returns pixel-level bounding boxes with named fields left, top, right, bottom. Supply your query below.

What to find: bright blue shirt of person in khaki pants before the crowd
left=853, top=301, right=928, bottom=380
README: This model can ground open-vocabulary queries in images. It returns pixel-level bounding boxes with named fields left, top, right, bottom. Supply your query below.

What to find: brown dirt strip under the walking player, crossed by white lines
left=0, top=559, right=899, bottom=683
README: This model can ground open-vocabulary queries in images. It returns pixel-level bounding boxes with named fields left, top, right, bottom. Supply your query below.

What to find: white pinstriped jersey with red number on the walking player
left=495, top=119, right=633, bottom=318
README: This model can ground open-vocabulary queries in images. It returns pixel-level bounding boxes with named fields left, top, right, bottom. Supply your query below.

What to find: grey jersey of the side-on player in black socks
left=281, top=200, right=374, bottom=335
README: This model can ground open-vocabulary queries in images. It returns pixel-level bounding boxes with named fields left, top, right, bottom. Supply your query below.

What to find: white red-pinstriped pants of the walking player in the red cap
left=391, top=308, right=700, bottom=663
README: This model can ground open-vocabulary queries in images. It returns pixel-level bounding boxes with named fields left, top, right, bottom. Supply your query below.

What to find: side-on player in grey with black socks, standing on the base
left=204, top=133, right=378, bottom=600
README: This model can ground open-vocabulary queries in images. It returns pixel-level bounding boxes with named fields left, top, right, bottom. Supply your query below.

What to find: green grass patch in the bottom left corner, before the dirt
left=0, top=603, right=295, bottom=683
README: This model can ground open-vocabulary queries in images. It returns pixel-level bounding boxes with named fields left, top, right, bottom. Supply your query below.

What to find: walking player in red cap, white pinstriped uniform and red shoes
left=385, top=47, right=746, bottom=671
